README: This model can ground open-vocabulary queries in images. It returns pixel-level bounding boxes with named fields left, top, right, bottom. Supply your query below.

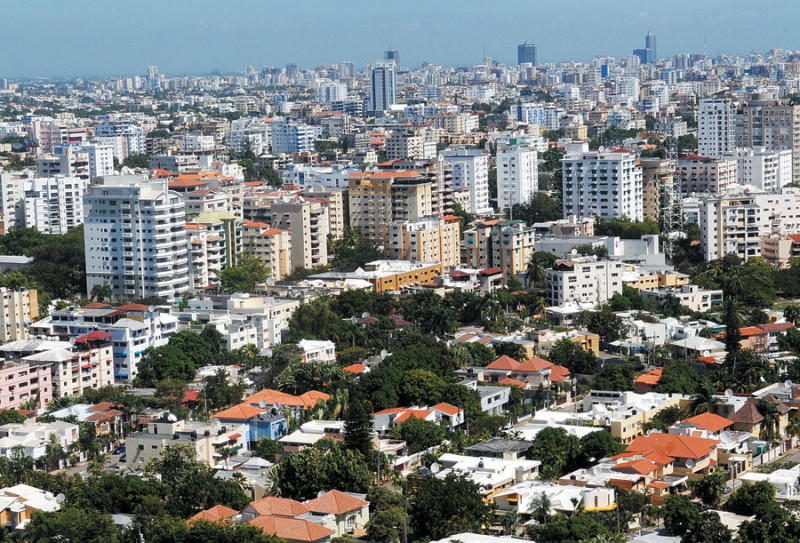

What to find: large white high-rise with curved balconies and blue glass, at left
left=84, top=175, right=189, bottom=301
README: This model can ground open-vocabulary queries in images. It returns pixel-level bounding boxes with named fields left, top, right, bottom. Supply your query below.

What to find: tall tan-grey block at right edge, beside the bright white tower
left=731, top=100, right=800, bottom=187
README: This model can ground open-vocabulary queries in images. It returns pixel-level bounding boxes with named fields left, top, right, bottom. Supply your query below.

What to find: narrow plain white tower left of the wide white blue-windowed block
left=497, top=145, right=539, bottom=211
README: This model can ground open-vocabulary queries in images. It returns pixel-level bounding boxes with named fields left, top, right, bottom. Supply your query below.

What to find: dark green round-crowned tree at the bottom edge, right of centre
left=411, top=474, right=490, bottom=540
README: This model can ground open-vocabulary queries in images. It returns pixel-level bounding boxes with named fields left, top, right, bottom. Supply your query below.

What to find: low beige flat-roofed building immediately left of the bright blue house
left=126, top=416, right=250, bottom=469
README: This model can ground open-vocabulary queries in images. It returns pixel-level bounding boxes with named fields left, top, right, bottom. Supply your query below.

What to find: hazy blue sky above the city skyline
left=0, top=0, right=800, bottom=78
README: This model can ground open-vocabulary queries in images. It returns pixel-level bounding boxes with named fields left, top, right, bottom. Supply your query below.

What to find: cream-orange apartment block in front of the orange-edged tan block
left=383, top=215, right=461, bottom=268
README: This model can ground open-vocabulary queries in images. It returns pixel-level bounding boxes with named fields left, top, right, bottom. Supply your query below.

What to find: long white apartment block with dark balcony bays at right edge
left=686, top=188, right=800, bottom=261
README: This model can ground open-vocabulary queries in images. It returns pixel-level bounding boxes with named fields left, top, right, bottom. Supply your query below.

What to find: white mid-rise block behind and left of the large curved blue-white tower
left=24, top=176, right=88, bottom=235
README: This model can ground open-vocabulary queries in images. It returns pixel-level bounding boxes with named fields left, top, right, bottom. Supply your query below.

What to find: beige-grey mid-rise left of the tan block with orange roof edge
left=270, top=196, right=329, bottom=270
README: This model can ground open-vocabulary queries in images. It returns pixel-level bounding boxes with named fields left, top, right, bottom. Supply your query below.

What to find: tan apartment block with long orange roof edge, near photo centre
left=349, top=171, right=433, bottom=243
